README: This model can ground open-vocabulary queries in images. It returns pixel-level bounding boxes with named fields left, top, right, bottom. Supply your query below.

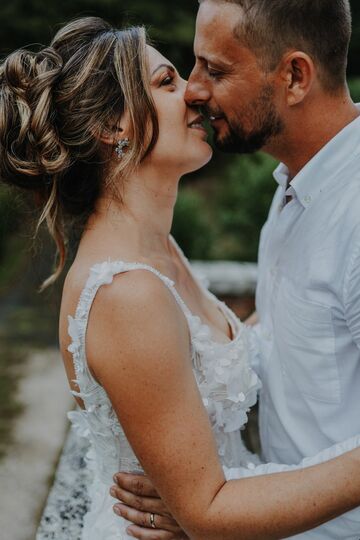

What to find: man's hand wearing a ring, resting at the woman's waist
left=110, top=473, right=187, bottom=540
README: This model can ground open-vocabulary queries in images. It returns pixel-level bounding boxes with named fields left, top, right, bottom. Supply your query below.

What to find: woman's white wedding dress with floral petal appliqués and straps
left=69, top=240, right=260, bottom=540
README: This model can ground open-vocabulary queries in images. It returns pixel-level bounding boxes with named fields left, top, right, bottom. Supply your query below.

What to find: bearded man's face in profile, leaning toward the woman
left=185, top=0, right=283, bottom=153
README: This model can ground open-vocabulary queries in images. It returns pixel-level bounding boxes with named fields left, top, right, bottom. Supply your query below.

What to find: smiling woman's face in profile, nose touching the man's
left=148, top=46, right=212, bottom=174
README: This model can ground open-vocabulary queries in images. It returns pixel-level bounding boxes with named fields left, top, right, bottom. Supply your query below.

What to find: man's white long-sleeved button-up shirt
left=227, top=108, right=360, bottom=540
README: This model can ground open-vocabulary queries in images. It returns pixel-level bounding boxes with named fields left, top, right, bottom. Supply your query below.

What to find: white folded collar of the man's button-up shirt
left=273, top=104, right=360, bottom=208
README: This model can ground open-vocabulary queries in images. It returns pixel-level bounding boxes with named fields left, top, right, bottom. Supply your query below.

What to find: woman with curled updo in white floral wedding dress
left=0, top=18, right=360, bottom=540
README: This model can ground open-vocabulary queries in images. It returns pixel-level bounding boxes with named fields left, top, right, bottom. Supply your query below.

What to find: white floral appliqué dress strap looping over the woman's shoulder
left=68, top=261, right=191, bottom=380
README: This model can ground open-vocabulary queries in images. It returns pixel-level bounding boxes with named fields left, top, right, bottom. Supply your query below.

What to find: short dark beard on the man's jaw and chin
left=214, top=85, right=284, bottom=154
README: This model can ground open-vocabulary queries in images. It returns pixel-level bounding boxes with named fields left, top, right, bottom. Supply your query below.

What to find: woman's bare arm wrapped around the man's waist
left=87, top=271, right=360, bottom=540
